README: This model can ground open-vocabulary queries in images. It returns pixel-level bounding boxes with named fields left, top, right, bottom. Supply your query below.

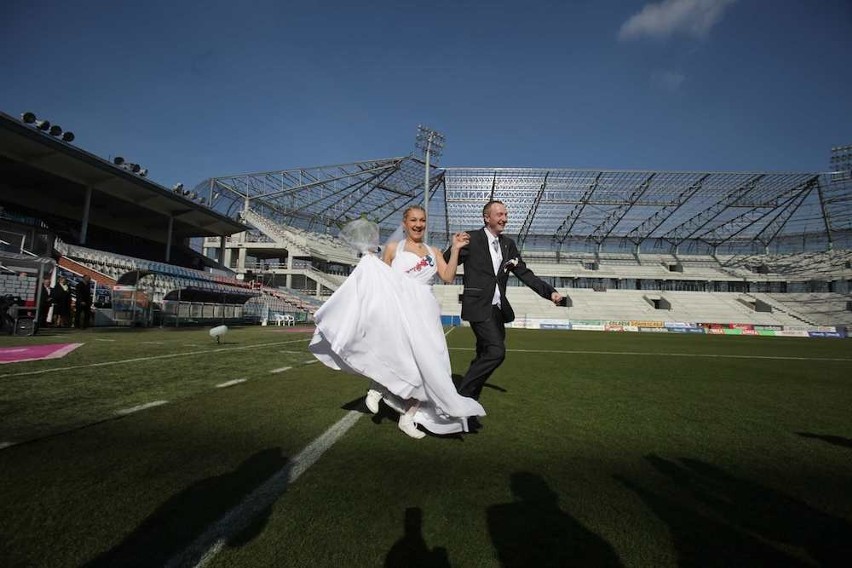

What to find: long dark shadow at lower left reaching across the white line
left=84, top=448, right=288, bottom=567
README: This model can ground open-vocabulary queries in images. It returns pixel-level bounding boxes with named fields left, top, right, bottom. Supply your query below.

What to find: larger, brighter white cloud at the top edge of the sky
left=618, top=0, right=736, bottom=40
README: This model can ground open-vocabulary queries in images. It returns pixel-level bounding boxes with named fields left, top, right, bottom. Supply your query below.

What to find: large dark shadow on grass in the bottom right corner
left=616, top=455, right=852, bottom=566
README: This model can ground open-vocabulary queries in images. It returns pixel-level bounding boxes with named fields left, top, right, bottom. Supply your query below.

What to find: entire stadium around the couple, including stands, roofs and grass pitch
left=0, top=113, right=852, bottom=566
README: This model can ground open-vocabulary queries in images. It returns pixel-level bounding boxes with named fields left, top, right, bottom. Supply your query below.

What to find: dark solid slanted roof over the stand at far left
left=0, top=113, right=245, bottom=247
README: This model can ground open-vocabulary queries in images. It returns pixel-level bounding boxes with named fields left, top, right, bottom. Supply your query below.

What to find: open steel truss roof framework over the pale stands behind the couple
left=196, top=156, right=852, bottom=253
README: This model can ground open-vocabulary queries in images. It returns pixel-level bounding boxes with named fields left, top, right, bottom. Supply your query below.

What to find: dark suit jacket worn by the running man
left=444, top=228, right=556, bottom=322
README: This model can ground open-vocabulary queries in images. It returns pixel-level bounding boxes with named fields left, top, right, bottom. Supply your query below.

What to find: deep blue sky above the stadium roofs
left=0, top=0, right=852, bottom=191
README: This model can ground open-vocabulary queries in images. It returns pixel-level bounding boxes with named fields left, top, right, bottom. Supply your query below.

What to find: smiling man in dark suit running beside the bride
left=444, top=200, right=562, bottom=412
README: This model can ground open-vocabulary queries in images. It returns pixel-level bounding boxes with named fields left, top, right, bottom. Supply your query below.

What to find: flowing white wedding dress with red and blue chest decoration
left=310, top=241, right=485, bottom=434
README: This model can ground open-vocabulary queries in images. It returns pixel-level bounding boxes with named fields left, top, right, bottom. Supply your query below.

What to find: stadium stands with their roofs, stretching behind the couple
left=0, top=108, right=852, bottom=333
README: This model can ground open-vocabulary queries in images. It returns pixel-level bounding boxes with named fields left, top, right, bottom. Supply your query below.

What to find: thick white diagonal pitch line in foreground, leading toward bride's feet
left=166, top=410, right=362, bottom=568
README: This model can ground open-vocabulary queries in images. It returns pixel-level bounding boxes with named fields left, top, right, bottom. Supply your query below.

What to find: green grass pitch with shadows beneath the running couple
left=0, top=327, right=852, bottom=567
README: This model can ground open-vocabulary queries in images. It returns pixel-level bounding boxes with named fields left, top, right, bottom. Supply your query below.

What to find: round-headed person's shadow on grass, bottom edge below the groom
left=486, top=471, right=622, bottom=567
